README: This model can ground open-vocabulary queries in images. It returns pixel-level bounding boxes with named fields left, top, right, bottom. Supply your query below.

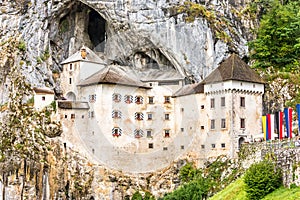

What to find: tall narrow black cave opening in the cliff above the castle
left=88, top=10, right=106, bottom=52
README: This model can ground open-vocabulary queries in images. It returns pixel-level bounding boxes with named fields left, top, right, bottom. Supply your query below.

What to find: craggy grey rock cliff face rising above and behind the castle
left=0, top=0, right=255, bottom=97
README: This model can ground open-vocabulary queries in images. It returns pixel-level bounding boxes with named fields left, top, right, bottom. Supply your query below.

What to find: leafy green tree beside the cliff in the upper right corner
left=249, top=0, right=300, bottom=71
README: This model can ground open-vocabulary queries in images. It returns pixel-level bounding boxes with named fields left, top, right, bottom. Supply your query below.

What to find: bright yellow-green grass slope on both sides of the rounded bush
left=209, top=178, right=300, bottom=200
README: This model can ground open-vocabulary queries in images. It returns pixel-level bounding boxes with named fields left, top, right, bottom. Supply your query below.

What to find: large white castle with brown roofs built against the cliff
left=35, top=47, right=264, bottom=172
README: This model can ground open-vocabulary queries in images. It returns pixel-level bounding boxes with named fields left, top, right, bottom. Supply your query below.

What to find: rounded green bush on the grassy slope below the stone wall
left=244, top=160, right=282, bottom=199
